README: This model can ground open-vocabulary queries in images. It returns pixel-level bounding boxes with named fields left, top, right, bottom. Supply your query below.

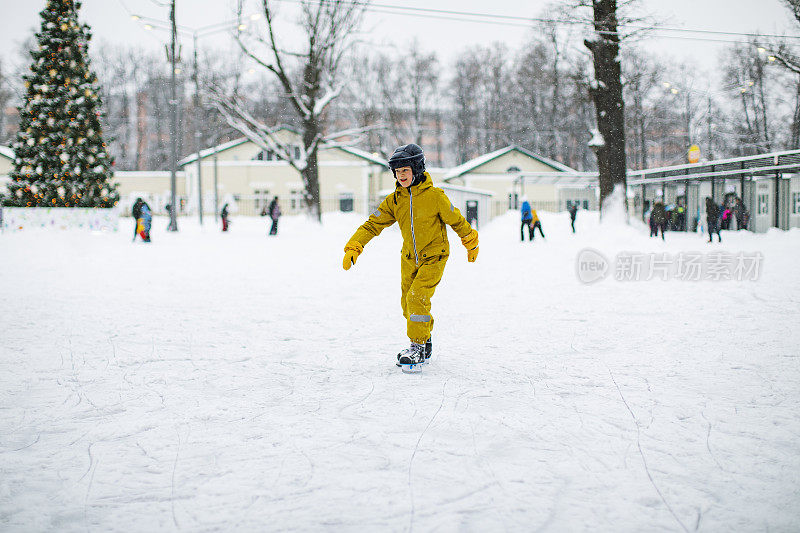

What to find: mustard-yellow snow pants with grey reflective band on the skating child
left=400, top=255, right=447, bottom=344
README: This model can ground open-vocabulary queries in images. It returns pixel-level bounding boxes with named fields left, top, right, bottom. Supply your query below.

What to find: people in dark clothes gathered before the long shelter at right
left=644, top=195, right=750, bottom=242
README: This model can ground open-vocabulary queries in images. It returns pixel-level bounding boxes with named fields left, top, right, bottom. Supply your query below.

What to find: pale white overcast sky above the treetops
left=0, top=0, right=800, bottom=78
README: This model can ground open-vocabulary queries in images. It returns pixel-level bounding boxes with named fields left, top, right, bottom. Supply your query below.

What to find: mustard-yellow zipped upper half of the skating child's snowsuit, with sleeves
left=350, top=172, right=478, bottom=265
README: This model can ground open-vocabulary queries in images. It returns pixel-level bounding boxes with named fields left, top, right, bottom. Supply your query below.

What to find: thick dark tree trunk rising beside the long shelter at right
left=584, top=0, right=626, bottom=209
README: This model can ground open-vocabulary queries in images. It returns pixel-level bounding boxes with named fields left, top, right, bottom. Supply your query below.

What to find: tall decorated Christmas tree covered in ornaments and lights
left=6, top=0, right=119, bottom=207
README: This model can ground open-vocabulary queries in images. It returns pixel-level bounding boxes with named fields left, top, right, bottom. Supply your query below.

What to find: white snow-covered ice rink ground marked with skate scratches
left=0, top=212, right=800, bottom=532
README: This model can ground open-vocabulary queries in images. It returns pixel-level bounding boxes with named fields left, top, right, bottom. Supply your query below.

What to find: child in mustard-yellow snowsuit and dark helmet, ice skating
left=342, top=144, right=478, bottom=364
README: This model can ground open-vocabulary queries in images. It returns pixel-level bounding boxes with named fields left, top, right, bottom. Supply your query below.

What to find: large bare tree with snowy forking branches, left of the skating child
left=211, top=0, right=365, bottom=221
